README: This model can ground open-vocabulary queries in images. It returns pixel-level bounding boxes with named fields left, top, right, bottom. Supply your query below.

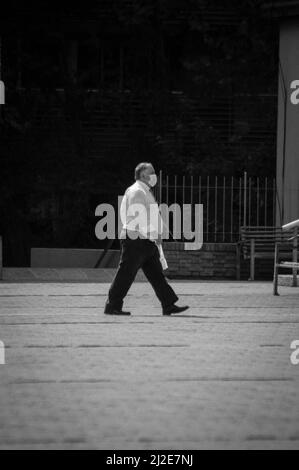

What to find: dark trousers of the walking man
left=106, top=238, right=178, bottom=310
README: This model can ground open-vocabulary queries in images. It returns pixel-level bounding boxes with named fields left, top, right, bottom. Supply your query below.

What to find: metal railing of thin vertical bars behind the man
left=155, top=172, right=277, bottom=243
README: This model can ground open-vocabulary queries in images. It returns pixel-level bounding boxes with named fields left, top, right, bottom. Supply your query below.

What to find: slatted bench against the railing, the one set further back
left=237, top=226, right=290, bottom=281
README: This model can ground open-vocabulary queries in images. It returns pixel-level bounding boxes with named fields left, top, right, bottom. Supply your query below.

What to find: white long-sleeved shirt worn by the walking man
left=120, top=180, right=163, bottom=242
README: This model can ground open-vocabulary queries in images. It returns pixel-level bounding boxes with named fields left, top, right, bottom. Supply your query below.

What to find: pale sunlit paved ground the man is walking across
left=0, top=282, right=299, bottom=450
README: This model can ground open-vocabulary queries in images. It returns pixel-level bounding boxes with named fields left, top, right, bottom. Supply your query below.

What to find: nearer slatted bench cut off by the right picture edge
left=273, top=220, right=299, bottom=295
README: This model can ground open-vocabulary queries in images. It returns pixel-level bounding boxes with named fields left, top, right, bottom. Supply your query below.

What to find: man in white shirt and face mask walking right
left=105, top=163, right=189, bottom=315
